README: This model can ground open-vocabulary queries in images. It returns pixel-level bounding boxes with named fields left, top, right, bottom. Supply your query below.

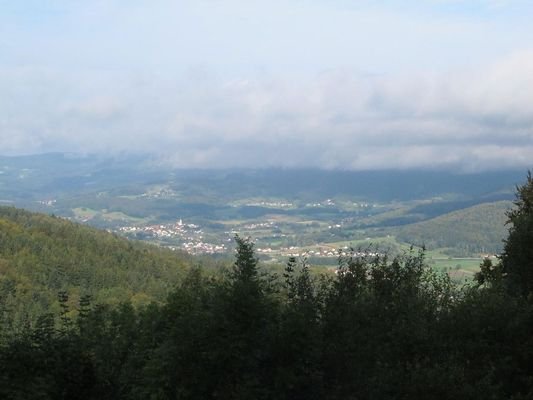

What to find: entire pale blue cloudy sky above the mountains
left=0, top=0, right=533, bottom=171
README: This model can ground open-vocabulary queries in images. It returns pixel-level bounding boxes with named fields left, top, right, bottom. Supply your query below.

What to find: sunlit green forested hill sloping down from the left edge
left=0, top=207, right=191, bottom=328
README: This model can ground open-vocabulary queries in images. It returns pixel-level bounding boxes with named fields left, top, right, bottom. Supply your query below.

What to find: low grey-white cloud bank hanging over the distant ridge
left=0, top=51, right=533, bottom=171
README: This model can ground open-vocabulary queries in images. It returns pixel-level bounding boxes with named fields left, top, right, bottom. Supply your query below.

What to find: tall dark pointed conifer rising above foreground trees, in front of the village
left=203, top=236, right=277, bottom=399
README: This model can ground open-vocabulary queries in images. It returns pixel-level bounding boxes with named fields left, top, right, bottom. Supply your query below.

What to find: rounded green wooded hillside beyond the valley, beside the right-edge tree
left=394, top=201, right=513, bottom=255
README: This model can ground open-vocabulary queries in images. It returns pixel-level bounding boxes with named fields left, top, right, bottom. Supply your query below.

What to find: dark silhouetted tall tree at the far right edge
left=501, top=171, right=533, bottom=297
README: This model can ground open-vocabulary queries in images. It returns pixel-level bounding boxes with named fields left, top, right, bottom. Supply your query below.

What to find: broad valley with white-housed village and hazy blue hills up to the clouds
left=0, top=154, right=521, bottom=278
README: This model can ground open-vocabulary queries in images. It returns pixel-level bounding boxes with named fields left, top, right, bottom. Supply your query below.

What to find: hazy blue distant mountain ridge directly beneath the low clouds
left=0, top=153, right=523, bottom=201
